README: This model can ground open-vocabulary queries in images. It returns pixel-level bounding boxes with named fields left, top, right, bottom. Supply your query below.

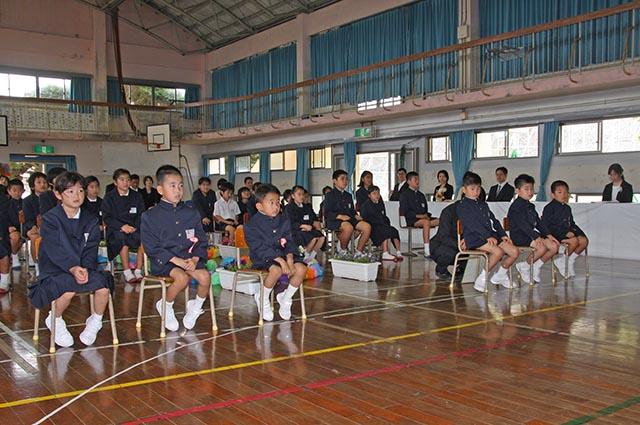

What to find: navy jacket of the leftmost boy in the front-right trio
left=456, top=197, right=507, bottom=249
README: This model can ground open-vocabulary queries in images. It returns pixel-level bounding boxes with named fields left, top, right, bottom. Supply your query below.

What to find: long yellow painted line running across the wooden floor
left=5, top=291, right=640, bottom=409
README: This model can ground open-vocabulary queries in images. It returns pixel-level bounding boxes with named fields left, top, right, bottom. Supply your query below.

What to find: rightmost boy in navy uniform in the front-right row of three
left=542, top=180, right=589, bottom=277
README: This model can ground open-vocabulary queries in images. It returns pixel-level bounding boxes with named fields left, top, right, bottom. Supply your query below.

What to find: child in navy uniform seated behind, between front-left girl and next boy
left=102, top=168, right=144, bottom=283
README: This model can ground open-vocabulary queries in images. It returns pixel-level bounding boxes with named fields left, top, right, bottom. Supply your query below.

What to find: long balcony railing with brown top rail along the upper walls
left=0, top=1, right=640, bottom=139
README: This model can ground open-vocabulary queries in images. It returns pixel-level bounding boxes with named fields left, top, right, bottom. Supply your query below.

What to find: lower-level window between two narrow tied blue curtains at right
left=475, top=126, right=538, bottom=158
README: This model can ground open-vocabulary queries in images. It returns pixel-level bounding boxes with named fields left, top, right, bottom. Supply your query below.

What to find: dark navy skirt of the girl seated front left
left=29, top=270, right=114, bottom=308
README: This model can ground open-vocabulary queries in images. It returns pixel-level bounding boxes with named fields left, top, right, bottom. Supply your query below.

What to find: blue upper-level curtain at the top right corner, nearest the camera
left=479, top=0, right=640, bottom=81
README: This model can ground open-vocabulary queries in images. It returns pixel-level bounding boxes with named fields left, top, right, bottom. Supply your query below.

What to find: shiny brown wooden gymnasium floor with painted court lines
left=0, top=258, right=640, bottom=425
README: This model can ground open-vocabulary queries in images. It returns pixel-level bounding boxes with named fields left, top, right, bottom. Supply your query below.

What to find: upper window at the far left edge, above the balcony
left=0, top=73, right=71, bottom=100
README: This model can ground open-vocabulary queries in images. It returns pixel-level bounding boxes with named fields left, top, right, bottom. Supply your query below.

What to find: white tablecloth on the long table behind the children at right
left=386, top=202, right=640, bottom=260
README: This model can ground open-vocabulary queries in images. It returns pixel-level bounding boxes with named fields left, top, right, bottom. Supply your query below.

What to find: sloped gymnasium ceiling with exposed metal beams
left=78, top=0, right=339, bottom=55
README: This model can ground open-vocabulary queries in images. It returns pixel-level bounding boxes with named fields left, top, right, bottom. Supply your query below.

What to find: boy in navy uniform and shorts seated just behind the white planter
left=324, top=170, right=371, bottom=255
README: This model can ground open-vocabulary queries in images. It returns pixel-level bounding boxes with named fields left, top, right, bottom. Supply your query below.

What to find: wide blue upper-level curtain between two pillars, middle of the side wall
left=311, top=0, right=458, bottom=107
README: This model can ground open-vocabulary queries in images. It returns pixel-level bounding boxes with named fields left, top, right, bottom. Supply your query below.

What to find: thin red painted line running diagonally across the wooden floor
left=123, top=328, right=566, bottom=425
